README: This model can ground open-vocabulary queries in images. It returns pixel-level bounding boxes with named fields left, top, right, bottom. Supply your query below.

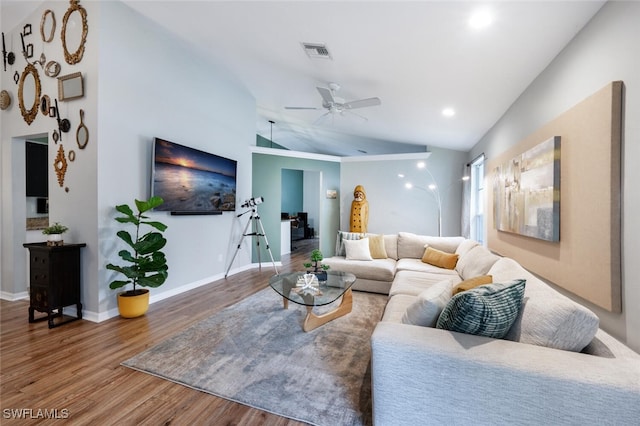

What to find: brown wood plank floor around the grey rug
left=0, top=239, right=318, bottom=426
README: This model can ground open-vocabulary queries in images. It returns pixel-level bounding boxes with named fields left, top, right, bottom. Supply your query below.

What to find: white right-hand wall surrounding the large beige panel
left=469, top=2, right=640, bottom=351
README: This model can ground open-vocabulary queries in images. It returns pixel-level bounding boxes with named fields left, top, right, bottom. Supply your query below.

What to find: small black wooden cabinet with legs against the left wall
left=23, top=242, right=86, bottom=328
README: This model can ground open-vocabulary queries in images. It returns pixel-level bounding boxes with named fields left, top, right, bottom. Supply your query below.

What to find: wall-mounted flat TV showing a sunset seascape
left=151, top=138, right=238, bottom=215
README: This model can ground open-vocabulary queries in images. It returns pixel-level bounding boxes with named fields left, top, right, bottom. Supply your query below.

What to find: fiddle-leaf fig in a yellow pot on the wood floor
left=107, top=197, right=169, bottom=318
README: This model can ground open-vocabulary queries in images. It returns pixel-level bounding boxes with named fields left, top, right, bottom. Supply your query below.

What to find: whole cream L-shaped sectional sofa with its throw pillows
left=323, top=232, right=640, bottom=425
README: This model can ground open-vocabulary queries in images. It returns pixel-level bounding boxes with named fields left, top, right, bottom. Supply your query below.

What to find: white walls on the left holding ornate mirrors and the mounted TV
left=0, top=1, right=256, bottom=321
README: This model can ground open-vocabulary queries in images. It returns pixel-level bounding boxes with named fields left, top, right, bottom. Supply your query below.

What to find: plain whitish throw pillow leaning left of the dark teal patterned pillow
left=402, top=280, right=453, bottom=327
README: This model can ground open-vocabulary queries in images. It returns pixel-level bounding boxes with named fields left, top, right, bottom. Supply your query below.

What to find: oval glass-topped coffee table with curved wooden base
left=269, top=271, right=356, bottom=331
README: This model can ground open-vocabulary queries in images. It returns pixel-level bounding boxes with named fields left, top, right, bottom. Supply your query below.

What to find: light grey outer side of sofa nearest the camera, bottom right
left=371, top=322, right=640, bottom=425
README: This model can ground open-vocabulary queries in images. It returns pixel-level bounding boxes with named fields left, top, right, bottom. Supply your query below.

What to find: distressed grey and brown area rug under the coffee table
left=122, top=288, right=387, bottom=426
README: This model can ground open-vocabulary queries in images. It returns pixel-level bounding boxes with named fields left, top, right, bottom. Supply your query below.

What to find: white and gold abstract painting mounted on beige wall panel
left=493, top=136, right=560, bottom=242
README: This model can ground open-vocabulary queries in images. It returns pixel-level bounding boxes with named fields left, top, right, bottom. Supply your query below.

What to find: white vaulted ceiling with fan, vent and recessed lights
left=2, top=0, right=605, bottom=156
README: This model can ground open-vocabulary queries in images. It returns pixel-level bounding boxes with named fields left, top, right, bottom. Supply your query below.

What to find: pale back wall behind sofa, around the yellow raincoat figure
left=339, top=148, right=466, bottom=236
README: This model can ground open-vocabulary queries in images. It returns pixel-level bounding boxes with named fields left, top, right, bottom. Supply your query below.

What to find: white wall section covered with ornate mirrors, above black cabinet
left=0, top=1, right=99, bottom=303
